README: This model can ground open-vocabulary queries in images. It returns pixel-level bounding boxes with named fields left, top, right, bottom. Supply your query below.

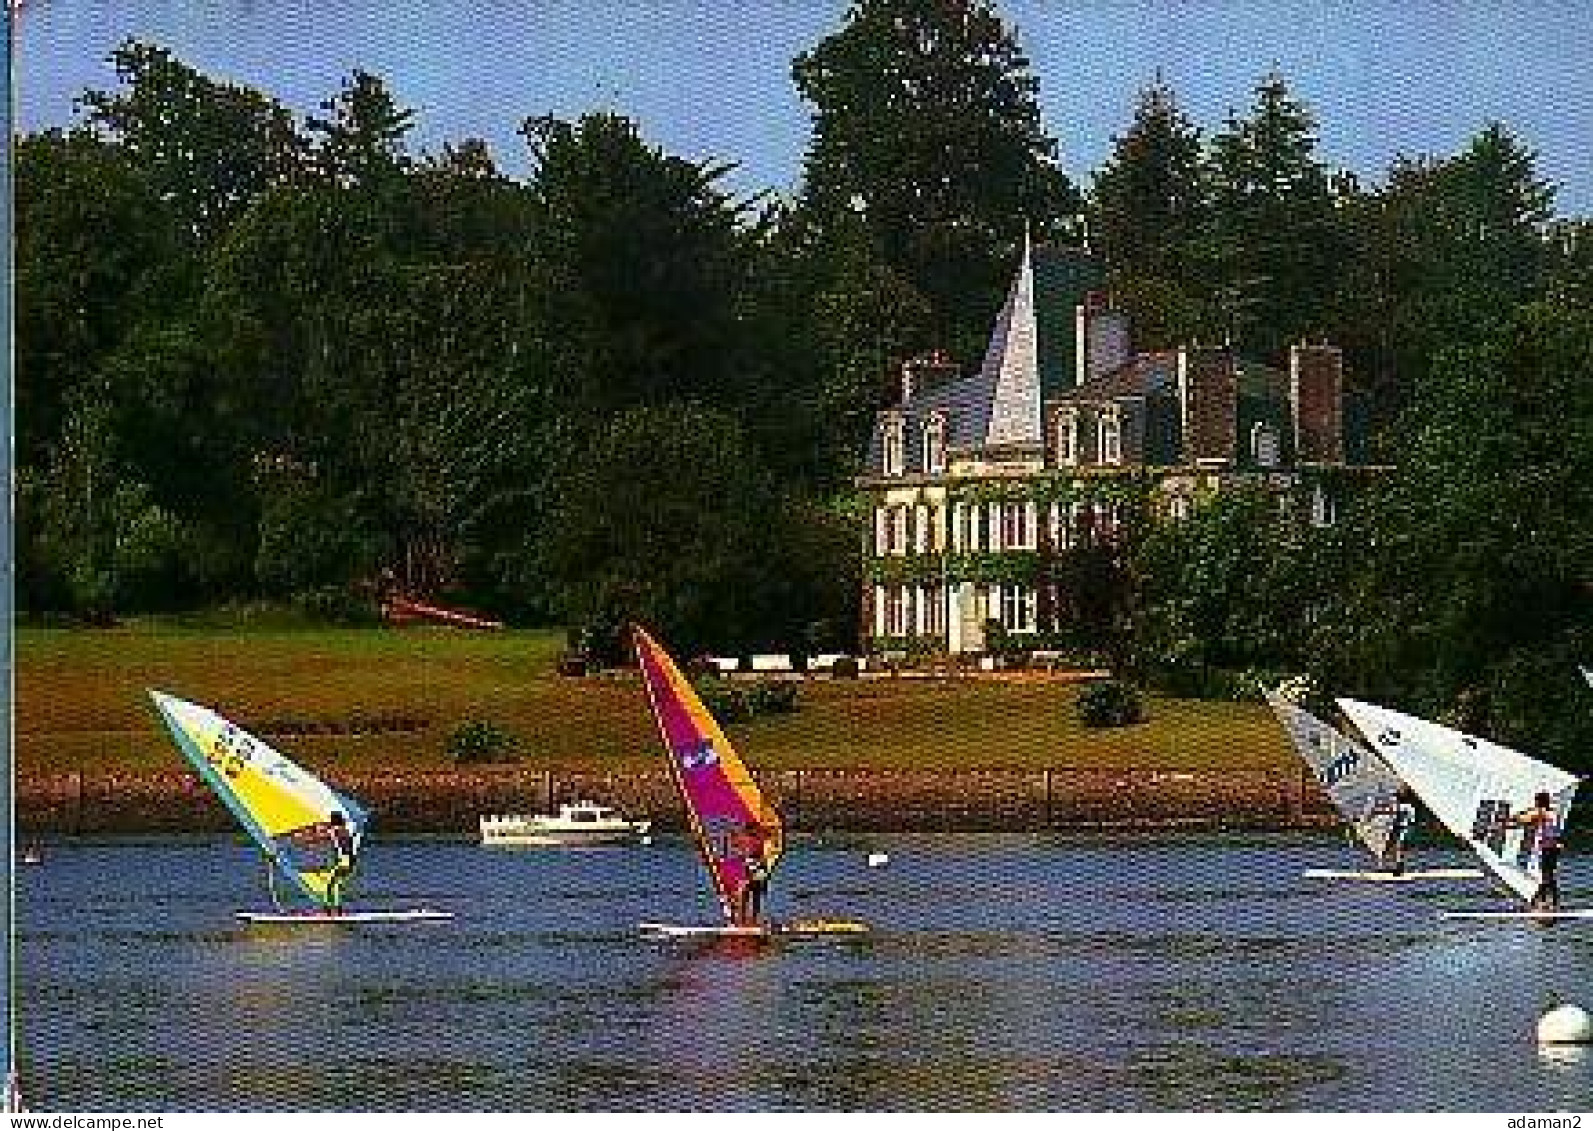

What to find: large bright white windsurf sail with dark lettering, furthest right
left=1338, top=699, right=1577, bottom=900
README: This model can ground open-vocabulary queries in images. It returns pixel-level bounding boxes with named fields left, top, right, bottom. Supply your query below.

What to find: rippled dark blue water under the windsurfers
left=14, top=835, right=1593, bottom=1112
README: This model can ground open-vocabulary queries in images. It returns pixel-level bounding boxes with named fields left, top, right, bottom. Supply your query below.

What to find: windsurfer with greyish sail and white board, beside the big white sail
left=1263, top=680, right=1481, bottom=882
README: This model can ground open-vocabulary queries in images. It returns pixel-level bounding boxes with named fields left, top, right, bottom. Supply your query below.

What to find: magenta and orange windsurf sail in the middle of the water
left=631, top=626, right=785, bottom=922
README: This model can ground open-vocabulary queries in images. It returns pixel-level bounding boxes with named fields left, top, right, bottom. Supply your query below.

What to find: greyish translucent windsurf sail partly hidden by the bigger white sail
left=1265, top=688, right=1400, bottom=863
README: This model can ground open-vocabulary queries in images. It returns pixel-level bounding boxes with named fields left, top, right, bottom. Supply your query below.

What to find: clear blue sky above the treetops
left=13, top=0, right=1593, bottom=215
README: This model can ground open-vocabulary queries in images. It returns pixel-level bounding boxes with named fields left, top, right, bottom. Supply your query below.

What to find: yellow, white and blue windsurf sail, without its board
left=150, top=691, right=368, bottom=906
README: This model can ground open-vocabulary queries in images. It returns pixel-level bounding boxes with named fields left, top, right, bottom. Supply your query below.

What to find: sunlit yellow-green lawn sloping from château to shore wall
left=16, top=621, right=1297, bottom=774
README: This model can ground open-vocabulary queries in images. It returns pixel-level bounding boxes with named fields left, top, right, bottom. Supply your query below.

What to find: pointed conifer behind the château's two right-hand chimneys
left=1206, top=73, right=1343, bottom=357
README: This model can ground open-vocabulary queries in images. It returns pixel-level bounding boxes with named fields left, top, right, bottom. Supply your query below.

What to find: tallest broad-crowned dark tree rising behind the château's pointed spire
left=792, top=0, right=1080, bottom=357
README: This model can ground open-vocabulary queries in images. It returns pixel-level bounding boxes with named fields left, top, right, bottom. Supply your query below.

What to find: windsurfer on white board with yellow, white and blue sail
left=150, top=690, right=452, bottom=924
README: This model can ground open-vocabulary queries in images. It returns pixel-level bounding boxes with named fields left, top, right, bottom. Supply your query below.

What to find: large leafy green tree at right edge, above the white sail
left=1338, top=303, right=1593, bottom=766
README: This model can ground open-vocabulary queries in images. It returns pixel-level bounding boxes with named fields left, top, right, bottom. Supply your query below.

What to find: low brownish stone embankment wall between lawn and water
left=13, top=768, right=1337, bottom=836
